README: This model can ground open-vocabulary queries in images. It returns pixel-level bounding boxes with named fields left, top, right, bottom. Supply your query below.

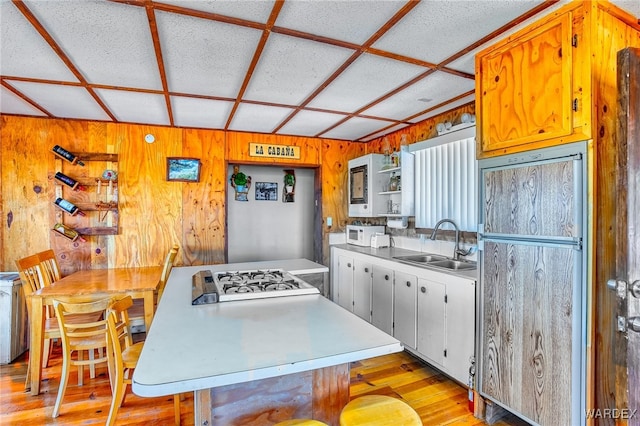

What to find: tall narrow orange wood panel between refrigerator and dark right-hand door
left=590, top=3, right=640, bottom=416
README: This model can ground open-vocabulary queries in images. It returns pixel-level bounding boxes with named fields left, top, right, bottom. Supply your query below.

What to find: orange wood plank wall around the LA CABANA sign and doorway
left=0, top=104, right=474, bottom=274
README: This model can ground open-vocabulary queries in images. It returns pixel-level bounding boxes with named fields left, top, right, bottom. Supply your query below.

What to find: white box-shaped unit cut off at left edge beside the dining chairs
left=0, top=272, right=29, bottom=364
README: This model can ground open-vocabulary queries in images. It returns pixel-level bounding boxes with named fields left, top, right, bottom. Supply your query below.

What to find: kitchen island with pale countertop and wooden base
left=132, top=259, right=403, bottom=425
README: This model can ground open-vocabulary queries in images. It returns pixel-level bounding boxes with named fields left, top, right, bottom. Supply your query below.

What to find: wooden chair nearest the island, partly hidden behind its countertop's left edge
left=106, top=296, right=180, bottom=426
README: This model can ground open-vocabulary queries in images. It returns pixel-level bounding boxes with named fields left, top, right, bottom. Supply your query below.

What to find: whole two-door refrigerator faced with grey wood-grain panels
left=477, top=143, right=587, bottom=426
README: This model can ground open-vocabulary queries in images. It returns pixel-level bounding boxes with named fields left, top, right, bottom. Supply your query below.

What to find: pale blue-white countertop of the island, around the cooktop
left=132, top=259, right=403, bottom=396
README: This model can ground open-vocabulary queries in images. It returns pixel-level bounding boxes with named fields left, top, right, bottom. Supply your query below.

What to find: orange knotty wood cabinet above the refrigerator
left=476, top=1, right=638, bottom=158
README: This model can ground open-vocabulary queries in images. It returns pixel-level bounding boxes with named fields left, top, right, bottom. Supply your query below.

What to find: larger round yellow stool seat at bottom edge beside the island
left=340, top=395, right=422, bottom=426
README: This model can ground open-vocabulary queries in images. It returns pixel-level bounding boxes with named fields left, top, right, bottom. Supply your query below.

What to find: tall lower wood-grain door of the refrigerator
left=480, top=241, right=581, bottom=426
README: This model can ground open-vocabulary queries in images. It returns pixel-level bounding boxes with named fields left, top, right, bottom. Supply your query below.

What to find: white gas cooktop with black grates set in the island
left=191, top=269, right=320, bottom=305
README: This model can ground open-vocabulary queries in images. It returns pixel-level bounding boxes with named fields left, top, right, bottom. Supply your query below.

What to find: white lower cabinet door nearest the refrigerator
left=444, top=277, right=476, bottom=383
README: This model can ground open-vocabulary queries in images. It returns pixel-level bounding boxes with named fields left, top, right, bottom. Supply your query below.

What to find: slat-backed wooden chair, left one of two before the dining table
left=51, top=296, right=114, bottom=418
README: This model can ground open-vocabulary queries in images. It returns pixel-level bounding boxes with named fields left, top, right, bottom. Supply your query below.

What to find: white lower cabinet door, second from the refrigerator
left=418, top=278, right=446, bottom=367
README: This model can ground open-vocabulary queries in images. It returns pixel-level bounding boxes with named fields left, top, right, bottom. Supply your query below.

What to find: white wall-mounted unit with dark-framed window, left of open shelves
left=349, top=154, right=389, bottom=218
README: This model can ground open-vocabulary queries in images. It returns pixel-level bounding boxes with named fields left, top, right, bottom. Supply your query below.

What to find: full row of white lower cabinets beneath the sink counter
left=331, top=247, right=476, bottom=384
